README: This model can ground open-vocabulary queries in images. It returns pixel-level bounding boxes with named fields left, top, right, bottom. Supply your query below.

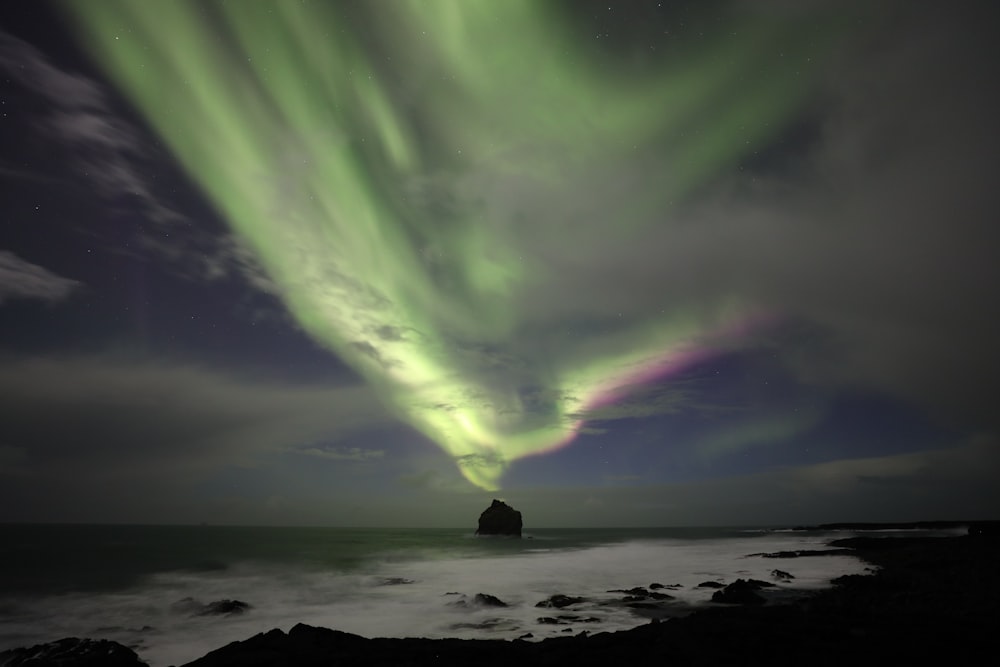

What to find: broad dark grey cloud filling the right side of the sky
left=465, top=2, right=1000, bottom=434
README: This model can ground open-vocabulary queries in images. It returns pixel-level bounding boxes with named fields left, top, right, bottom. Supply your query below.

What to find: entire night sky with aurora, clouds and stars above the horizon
left=0, top=0, right=1000, bottom=528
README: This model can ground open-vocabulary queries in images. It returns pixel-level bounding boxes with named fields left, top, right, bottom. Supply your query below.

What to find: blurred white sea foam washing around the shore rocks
left=0, top=533, right=864, bottom=667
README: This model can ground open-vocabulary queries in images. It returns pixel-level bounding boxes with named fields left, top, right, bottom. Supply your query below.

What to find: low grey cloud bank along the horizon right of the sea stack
left=505, top=436, right=1000, bottom=528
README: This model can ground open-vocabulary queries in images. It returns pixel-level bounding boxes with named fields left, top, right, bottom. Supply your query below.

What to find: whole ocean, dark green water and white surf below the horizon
left=0, top=525, right=920, bottom=667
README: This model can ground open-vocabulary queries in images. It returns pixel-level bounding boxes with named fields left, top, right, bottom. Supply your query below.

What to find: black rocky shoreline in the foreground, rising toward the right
left=0, top=530, right=1000, bottom=667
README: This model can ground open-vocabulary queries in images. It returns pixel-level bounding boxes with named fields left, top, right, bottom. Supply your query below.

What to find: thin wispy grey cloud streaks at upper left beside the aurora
left=0, top=25, right=290, bottom=308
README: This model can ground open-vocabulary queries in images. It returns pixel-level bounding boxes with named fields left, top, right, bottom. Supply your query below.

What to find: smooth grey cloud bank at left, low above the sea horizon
left=0, top=357, right=390, bottom=479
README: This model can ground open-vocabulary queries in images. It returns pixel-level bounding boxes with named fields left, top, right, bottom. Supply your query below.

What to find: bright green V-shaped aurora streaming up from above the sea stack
left=65, top=0, right=832, bottom=490
